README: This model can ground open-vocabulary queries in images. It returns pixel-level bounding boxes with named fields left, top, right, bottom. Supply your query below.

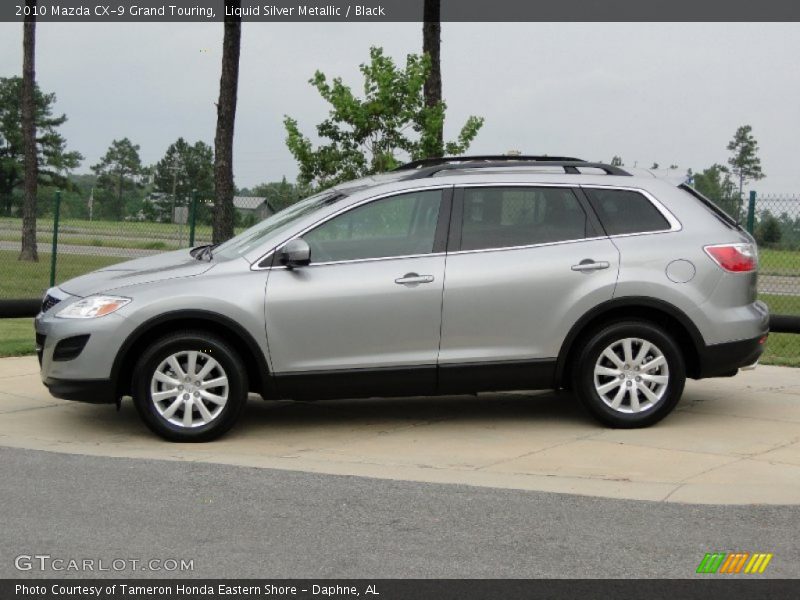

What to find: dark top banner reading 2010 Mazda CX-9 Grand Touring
left=0, top=0, right=800, bottom=23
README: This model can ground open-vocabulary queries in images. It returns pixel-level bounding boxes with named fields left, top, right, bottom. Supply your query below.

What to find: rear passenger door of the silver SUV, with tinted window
left=439, top=185, right=619, bottom=392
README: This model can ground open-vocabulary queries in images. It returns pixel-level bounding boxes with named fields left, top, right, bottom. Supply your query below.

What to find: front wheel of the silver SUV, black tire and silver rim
left=132, top=331, right=248, bottom=442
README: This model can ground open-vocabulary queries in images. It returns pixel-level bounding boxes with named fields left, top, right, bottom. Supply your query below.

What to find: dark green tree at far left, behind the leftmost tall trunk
left=0, top=77, right=83, bottom=215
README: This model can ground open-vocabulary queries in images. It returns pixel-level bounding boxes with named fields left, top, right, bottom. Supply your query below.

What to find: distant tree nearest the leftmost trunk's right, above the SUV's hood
left=92, top=138, right=146, bottom=220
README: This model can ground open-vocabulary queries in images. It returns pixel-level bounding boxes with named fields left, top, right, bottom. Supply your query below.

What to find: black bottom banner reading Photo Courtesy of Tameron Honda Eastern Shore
left=0, top=576, right=800, bottom=600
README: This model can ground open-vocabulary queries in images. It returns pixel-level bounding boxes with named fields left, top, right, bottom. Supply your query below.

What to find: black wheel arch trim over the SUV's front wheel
left=111, top=310, right=275, bottom=398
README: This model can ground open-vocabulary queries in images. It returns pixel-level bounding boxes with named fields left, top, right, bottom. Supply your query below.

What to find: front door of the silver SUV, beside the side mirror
left=266, top=189, right=449, bottom=398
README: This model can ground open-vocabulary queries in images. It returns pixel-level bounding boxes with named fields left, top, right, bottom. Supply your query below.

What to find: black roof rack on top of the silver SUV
left=394, top=155, right=630, bottom=179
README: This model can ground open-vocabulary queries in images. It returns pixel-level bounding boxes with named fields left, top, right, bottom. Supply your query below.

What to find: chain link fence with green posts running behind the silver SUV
left=0, top=192, right=800, bottom=365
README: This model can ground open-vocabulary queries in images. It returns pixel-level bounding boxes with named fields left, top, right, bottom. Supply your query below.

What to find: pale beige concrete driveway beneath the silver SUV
left=0, top=357, right=800, bottom=504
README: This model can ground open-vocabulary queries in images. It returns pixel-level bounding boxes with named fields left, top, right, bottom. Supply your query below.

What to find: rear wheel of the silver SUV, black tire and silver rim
left=574, top=321, right=686, bottom=429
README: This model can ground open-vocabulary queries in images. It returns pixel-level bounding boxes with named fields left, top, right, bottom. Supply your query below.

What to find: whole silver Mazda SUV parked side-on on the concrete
left=36, top=157, right=768, bottom=441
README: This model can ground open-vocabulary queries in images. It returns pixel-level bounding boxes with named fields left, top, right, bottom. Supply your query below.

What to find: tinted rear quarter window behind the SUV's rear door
left=584, top=188, right=670, bottom=235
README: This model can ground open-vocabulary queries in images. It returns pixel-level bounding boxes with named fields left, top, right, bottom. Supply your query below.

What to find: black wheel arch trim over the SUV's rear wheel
left=555, top=296, right=705, bottom=388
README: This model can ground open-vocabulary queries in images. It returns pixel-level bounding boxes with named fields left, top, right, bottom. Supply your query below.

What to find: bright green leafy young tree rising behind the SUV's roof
left=284, top=47, right=483, bottom=187
